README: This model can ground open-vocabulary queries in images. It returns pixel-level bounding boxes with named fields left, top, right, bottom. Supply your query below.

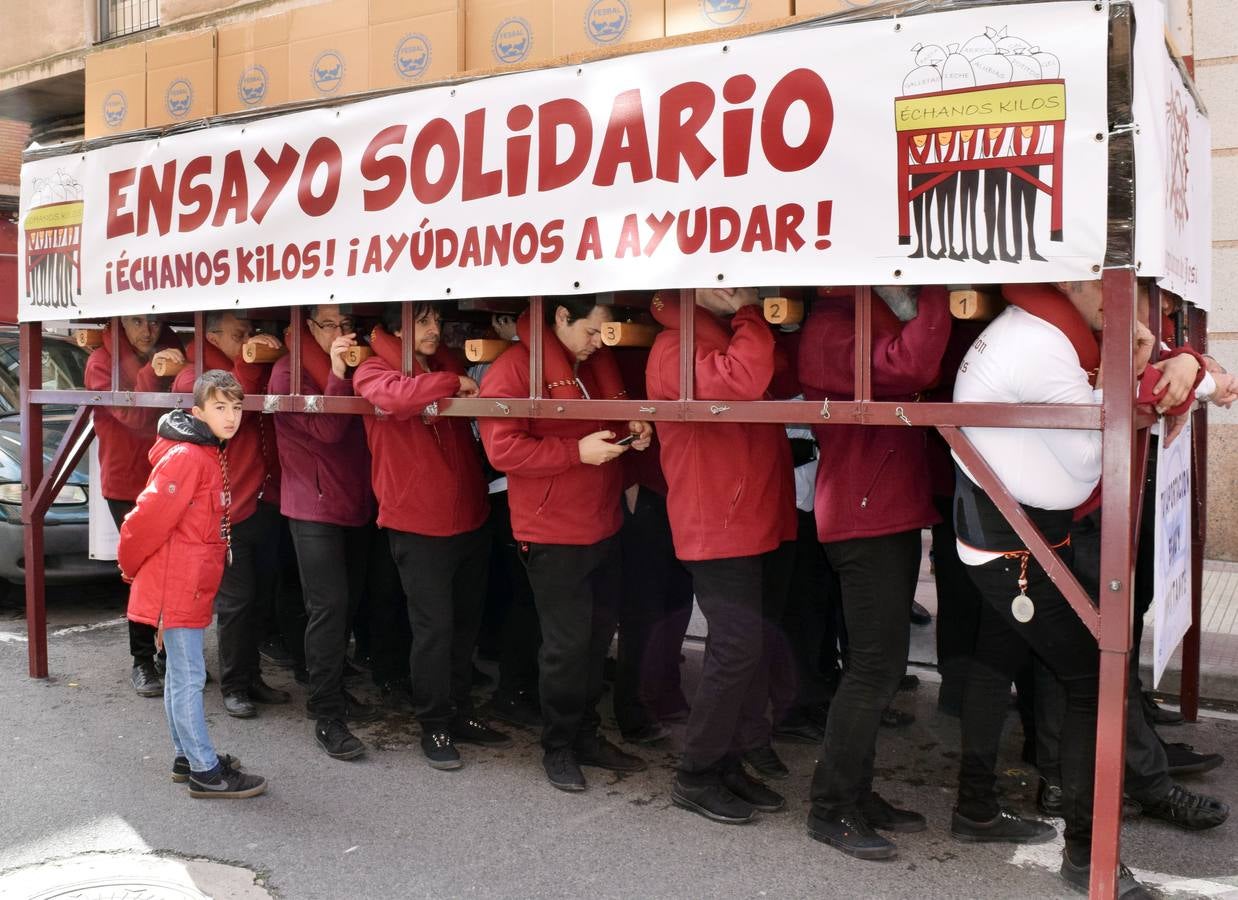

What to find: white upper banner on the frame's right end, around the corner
left=1134, top=0, right=1212, bottom=309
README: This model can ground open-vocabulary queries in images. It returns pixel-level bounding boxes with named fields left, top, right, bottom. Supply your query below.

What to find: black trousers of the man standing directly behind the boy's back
left=215, top=500, right=280, bottom=696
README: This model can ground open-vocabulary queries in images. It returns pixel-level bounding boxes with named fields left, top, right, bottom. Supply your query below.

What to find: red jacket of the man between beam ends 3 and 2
left=645, top=297, right=796, bottom=560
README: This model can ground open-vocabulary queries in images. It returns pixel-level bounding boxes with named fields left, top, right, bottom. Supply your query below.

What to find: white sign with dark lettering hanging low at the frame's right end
left=1153, top=417, right=1193, bottom=687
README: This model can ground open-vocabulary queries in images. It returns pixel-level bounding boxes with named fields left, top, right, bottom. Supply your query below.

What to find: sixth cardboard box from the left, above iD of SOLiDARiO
left=464, top=0, right=555, bottom=69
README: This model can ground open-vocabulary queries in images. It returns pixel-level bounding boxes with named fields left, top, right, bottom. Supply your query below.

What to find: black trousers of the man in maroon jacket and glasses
left=288, top=519, right=375, bottom=719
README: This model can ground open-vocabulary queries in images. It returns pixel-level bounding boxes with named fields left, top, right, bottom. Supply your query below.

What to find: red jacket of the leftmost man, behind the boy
left=85, top=328, right=181, bottom=503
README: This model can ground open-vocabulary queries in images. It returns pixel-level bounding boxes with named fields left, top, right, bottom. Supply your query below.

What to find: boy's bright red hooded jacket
left=116, top=410, right=228, bottom=628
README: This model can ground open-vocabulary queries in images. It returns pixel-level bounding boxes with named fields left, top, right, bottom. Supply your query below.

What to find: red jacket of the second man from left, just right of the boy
left=172, top=343, right=280, bottom=525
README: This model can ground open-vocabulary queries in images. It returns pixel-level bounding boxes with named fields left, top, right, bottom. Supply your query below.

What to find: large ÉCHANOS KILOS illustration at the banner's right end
left=894, top=27, right=1066, bottom=262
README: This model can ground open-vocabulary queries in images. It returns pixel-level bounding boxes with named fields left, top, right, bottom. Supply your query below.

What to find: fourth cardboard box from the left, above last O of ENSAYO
left=288, top=0, right=370, bottom=100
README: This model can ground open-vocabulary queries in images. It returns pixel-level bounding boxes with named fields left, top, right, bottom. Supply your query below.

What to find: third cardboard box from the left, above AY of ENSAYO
left=215, top=14, right=292, bottom=113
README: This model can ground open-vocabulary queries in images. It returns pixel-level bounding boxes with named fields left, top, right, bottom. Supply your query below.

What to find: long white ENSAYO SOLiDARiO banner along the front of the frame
left=20, top=2, right=1108, bottom=319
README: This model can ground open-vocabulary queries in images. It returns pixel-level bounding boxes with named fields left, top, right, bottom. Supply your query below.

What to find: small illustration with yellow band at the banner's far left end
left=22, top=170, right=82, bottom=309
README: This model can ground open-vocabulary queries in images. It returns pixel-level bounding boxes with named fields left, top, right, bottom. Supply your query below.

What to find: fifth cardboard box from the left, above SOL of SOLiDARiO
left=370, top=0, right=464, bottom=90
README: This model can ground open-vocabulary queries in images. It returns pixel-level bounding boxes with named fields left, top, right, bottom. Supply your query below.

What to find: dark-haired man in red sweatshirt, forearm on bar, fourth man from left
left=353, top=303, right=511, bottom=769
